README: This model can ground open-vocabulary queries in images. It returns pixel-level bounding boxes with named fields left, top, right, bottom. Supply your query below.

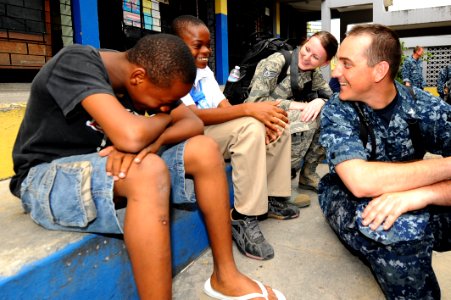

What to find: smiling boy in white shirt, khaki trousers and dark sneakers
left=172, top=15, right=299, bottom=260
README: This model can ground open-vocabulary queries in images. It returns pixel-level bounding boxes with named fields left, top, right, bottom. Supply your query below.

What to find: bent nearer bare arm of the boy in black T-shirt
left=81, top=94, right=172, bottom=153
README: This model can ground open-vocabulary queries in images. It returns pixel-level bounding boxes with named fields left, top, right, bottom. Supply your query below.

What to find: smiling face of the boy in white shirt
left=180, top=25, right=211, bottom=69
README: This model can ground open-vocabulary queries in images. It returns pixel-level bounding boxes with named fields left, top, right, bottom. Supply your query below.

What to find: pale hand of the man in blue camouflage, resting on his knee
left=362, top=189, right=428, bottom=230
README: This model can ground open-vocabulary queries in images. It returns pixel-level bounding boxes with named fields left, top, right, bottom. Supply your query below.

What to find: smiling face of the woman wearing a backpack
left=298, top=36, right=328, bottom=71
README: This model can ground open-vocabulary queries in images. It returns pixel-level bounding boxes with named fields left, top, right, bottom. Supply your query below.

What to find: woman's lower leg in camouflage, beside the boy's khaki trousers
left=298, top=129, right=326, bottom=192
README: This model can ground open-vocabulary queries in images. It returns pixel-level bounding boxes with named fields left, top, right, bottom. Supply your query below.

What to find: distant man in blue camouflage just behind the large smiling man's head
left=401, top=46, right=426, bottom=89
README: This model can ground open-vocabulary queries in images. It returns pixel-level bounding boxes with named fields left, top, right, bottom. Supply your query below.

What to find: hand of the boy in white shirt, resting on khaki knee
left=244, top=101, right=288, bottom=135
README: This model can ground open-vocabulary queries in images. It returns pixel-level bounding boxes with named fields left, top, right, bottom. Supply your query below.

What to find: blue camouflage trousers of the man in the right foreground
left=318, top=174, right=451, bottom=299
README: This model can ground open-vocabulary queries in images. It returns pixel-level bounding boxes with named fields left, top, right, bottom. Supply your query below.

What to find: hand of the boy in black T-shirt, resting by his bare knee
left=99, top=146, right=136, bottom=181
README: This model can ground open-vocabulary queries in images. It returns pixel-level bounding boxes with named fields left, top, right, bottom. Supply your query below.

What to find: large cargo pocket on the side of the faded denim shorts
left=48, top=161, right=97, bottom=227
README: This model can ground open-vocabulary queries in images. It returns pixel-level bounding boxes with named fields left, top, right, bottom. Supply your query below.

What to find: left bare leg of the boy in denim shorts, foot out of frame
left=114, top=154, right=172, bottom=299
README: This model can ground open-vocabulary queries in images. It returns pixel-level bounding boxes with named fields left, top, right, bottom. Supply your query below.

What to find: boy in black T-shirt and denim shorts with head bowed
left=10, top=34, right=283, bottom=299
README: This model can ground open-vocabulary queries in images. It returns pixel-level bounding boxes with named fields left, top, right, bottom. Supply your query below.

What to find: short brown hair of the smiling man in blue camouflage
left=346, top=24, right=402, bottom=80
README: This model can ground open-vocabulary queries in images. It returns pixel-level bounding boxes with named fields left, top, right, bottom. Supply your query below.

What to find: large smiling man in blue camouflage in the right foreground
left=319, top=24, right=451, bottom=299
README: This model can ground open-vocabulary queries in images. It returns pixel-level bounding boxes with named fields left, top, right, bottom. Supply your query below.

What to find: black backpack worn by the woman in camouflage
left=224, top=32, right=293, bottom=104
